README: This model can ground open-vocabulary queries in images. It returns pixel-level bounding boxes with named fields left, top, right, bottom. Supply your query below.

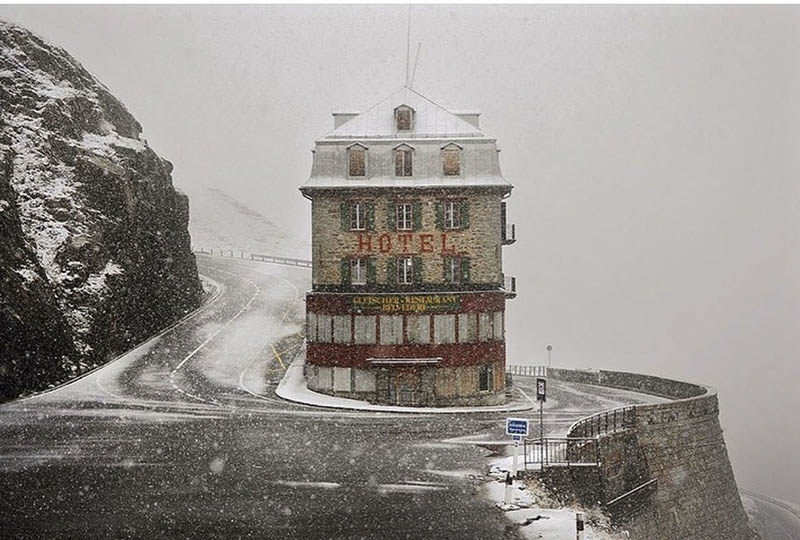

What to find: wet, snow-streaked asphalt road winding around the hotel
left=0, top=256, right=688, bottom=539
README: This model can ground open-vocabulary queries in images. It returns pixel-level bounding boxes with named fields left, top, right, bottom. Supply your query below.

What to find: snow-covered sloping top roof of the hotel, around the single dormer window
left=320, top=87, right=487, bottom=140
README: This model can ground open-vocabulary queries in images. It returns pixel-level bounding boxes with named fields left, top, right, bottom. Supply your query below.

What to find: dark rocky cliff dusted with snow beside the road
left=0, top=21, right=202, bottom=400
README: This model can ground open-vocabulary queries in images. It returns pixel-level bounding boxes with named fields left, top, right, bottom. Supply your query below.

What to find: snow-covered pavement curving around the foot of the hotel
left=275, top=355, right=533, bottom=414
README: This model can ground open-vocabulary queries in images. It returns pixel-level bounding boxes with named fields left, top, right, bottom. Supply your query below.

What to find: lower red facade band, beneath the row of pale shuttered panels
left=306, top=341, right=506, bottom=368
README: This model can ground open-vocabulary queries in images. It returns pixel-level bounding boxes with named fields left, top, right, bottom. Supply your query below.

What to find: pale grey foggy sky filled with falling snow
left=0, top=5, right=800, bottom=503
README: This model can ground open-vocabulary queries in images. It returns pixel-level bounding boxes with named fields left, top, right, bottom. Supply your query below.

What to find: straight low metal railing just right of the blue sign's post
left=523, top=437, right=600, bottom=469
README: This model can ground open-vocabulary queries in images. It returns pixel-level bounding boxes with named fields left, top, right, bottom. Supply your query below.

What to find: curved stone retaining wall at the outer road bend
left=548, top=369, right=759, bottom=540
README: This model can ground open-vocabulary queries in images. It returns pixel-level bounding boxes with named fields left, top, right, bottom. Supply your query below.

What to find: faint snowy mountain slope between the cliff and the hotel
left=189, top=188, right=311, bottom=259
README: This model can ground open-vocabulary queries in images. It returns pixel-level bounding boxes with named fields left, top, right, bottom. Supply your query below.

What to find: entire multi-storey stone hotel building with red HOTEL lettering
left=300, top=88, right=511, bottom=407
